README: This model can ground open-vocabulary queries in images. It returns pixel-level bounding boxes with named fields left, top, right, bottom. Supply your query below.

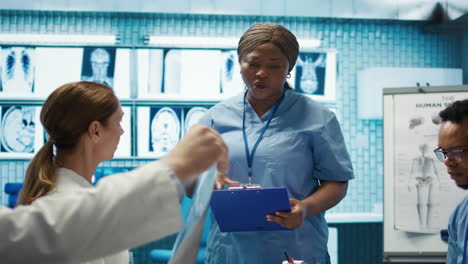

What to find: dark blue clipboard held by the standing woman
left=210, top=188, right=291, bottom=232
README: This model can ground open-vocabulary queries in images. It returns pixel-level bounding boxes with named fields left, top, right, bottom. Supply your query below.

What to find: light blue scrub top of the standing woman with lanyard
left=201, top=89, right=354, bottom=264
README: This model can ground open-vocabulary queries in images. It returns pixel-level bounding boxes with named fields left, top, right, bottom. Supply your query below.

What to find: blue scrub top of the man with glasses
left=446, top=196, right=468, bottom=264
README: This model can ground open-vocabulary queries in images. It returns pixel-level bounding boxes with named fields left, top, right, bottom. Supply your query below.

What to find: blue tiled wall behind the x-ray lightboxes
left=0, top=10, right=462, bottom=217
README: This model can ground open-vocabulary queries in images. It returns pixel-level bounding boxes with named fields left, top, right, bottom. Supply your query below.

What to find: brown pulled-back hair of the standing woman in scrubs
left=237, top=23, right=299, bottom=72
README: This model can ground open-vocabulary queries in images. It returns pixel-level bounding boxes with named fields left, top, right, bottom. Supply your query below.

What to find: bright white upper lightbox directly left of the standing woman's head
left=137, top=49, right=244, bottom=101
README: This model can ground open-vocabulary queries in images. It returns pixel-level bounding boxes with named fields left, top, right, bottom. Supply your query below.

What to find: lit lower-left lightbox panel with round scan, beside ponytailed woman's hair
left=0, top=106, right=44, bottom=158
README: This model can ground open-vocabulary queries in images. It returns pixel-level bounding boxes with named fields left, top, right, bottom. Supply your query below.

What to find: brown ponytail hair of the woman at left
left=18, top=82, right=120, bottom=205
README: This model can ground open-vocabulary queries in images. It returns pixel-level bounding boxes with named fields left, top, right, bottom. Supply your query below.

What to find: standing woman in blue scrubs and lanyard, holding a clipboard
left=201, top=23, right=354, bottom=264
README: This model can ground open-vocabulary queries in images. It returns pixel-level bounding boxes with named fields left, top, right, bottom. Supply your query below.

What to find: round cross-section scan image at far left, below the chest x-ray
left=1, top=106, right=36, bottom=153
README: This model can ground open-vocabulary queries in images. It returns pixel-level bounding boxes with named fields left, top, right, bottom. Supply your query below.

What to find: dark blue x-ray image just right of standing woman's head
left=294, top=52, right=327, bottom=95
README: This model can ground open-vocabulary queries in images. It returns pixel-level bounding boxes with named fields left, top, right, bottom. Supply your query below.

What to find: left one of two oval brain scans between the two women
left=148, top=107, right=181, bottom=157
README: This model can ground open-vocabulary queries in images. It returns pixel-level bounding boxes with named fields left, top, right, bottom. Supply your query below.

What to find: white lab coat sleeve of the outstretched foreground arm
left=0, top=162, right=182, bottom=264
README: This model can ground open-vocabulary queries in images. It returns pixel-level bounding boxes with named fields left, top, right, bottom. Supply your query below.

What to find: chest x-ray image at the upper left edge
left=0, top=47, right=35, bottom=96
